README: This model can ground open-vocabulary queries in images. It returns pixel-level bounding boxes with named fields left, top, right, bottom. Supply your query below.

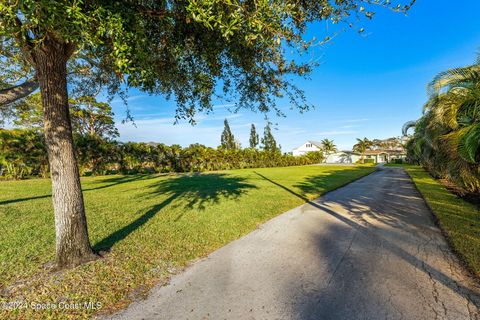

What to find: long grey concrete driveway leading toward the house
left=109, top=167, right=480, bottom=320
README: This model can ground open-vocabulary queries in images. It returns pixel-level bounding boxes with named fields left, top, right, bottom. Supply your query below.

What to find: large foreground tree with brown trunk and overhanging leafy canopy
left=0, top=0, right=414, bottom=267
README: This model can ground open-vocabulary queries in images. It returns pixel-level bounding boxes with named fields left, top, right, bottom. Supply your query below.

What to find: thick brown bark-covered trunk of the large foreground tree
left=33, top=36, right=96, bottom=268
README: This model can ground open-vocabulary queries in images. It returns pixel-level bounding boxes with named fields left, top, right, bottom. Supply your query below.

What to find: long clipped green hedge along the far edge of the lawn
left=0, top=129, right=324, bottom=179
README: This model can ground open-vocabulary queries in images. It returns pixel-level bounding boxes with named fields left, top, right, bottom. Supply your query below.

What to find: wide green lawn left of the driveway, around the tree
left=0, top=166, right=375, bottom=319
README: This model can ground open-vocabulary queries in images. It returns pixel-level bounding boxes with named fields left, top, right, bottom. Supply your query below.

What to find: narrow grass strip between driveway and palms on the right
left=403, top=165, right=480, bottom=277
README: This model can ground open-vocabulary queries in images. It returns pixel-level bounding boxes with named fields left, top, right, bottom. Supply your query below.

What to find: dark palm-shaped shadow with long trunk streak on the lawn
left=94, top=173, right=257, bottom=251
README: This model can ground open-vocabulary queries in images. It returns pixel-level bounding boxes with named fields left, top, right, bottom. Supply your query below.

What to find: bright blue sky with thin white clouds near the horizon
left=112, top=0, right=480, bottom=152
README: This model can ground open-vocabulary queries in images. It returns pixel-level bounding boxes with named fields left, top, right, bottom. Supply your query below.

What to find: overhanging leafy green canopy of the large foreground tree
left=0, top=0, right=414, bottom=122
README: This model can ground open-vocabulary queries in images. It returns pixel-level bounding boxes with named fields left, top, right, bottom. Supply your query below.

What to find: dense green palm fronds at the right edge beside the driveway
left=407, top=56, right=480, bottom=192
